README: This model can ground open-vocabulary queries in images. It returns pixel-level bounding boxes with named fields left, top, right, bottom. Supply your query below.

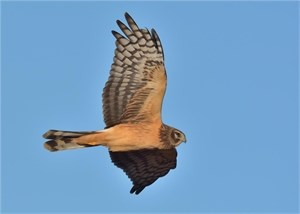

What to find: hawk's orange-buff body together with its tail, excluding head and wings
left=44, top=123, right=168, bottom=152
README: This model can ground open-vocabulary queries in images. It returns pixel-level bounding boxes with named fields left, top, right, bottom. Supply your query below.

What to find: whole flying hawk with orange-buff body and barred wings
left=43, top=13, right=186, bottom=194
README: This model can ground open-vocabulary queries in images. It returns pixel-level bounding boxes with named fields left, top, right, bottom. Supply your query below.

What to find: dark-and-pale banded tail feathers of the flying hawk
left=43, top=130, right=99, bottom=152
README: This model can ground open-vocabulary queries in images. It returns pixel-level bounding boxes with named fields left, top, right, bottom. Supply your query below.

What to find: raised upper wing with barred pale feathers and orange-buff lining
left=102, top=13, right=166, bottom=127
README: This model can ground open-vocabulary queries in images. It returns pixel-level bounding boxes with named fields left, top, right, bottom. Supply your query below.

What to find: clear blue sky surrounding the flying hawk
left=1, top=1, right=299, bottom=213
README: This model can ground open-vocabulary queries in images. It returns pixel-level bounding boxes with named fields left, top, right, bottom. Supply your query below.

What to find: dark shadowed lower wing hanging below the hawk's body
left=109, top=148, right=177, bottom=194
